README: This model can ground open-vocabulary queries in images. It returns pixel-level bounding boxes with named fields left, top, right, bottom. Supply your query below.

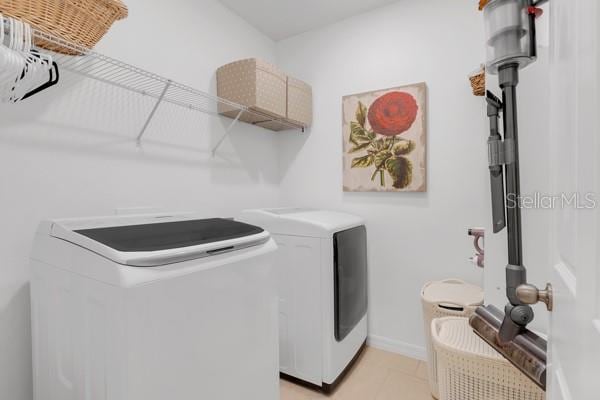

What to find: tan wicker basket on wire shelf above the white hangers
left=0, top=0, right=128, bottom=55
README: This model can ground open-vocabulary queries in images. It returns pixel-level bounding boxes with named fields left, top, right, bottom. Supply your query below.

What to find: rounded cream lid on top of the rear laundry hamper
left=422, top=279, right=483, bottom=306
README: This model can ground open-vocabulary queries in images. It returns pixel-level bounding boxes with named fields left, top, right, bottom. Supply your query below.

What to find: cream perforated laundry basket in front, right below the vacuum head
left=431, top=317, right=545, bottom=400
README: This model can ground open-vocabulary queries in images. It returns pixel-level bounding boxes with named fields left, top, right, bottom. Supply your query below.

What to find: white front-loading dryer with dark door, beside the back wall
left=238, top=209, right=367, bottom=392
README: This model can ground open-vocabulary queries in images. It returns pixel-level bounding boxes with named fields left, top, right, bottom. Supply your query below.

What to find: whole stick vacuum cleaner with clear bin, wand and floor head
left=470, top=0, right=552, bottom=390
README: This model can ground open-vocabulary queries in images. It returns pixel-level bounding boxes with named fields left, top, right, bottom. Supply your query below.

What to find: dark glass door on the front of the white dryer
left=333, top=226, right=367, bottom=342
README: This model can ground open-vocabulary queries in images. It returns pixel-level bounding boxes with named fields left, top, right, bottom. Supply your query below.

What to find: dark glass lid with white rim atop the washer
left=50, top=216, right=269, bottom=267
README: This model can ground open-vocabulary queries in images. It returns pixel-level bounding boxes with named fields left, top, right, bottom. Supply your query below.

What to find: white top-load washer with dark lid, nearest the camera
left=31, top=215, right=279, bottom=400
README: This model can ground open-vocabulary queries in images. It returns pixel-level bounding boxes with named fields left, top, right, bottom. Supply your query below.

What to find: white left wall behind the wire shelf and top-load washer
left=0, top=0, right=279, bottom=400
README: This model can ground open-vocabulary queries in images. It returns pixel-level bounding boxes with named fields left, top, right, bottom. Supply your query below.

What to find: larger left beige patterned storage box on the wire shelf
left=217, top=58, right=287, bottom=129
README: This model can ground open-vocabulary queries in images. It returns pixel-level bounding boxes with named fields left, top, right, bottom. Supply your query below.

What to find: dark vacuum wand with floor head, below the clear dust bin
left=476, top=64, right=550, bottom=390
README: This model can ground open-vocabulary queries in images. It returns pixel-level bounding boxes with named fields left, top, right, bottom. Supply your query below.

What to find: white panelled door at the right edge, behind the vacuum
left=548, top=0, right=600, bottom=400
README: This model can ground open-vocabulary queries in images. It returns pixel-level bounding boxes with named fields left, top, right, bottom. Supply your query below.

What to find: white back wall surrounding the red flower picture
left=277, top=0, right=491, bottom=355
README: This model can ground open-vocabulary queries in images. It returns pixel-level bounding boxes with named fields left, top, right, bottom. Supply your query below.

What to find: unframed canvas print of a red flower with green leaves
left=343, top=83, right=427, bottom=192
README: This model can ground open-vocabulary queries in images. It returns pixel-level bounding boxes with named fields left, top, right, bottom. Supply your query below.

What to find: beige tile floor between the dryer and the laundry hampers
left=281, top=347, right=433, bottom=400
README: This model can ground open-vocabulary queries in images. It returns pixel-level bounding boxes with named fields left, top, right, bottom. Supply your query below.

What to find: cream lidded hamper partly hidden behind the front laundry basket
left=421, top=279, right=483, bottom=398
